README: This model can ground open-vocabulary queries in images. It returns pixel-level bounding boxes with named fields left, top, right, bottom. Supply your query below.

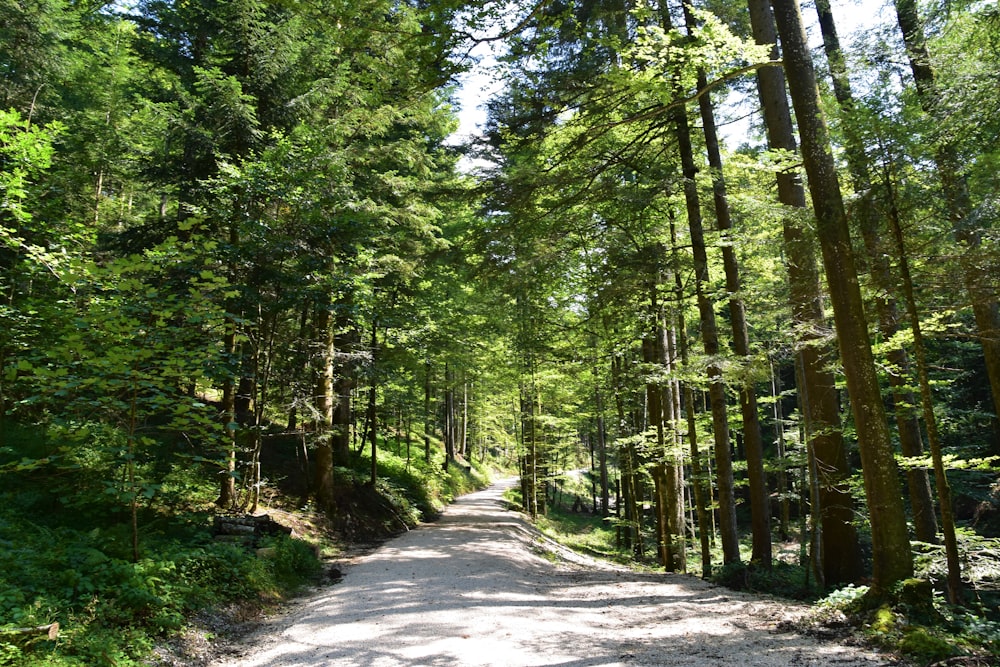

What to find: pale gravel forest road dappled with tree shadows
left=216, top=485, right=887, bottom=667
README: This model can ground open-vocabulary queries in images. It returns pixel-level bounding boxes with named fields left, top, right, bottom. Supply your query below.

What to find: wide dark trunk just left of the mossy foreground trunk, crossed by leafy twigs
left=748, top=0, right=862, bottom=584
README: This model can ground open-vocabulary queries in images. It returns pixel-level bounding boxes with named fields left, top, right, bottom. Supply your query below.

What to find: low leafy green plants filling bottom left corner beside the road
left=0, top=427, right=320, bottom=665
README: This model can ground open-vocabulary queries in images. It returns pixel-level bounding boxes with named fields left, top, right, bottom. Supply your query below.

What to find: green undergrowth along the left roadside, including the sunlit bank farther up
left=0, top=429, right=488, bottom=667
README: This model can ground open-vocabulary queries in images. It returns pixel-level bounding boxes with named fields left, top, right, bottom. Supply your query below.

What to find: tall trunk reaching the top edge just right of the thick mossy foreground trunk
left=816, top=0, right=937, bottom=543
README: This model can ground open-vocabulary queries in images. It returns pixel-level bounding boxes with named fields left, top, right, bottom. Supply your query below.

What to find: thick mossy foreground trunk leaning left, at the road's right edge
left=772, top=0, right=913, bottom=594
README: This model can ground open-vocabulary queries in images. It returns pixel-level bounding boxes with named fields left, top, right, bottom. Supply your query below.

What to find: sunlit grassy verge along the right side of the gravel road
left=507, top=478, right=1000, bottom=667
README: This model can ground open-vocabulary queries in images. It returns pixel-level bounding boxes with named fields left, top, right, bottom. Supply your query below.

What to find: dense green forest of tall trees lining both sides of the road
left=0, top=0, right=1000, bottom=665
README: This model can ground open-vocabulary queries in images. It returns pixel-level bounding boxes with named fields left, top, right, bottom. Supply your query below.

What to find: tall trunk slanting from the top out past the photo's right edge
left=895, top=0, right=1000, bottom=452
